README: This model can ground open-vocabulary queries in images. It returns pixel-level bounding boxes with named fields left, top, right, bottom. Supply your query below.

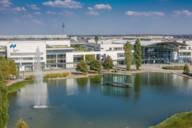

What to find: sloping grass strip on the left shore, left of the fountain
left=8, top=80, right=33, bottom=93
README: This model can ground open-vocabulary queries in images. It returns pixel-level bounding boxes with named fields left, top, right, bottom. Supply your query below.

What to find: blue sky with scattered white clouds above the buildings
left=0, top=0, right=192, bottom=35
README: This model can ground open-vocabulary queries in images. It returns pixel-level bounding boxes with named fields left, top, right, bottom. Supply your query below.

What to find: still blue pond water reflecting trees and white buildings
left=9, top=73, right=192, bottom=128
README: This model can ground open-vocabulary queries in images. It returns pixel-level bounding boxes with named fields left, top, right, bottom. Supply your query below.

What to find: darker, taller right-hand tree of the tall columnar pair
left=134, top=39, right=142, bottom=70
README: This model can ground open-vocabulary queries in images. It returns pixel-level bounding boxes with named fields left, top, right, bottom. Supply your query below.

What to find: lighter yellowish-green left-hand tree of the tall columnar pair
left=123, top=42, right=132, bottom=70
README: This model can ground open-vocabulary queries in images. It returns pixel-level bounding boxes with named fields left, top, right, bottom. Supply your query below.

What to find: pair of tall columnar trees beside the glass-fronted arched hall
left=123, top=39, right=142, bottom=70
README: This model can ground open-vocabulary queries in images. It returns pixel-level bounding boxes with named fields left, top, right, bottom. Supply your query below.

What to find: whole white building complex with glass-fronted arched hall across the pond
left=0, top=35, right=192, bottom=71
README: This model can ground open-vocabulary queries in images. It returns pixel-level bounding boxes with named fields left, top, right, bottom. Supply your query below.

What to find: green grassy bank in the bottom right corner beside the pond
left=151, top=112, right=192, bottom=128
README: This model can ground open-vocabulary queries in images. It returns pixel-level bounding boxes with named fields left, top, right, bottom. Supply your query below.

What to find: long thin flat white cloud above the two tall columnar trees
left=125, top=11, right=165, bottom=16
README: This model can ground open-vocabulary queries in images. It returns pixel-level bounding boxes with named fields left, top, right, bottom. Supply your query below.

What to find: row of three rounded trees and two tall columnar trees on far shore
left=76, top=39, right=142, bottom=73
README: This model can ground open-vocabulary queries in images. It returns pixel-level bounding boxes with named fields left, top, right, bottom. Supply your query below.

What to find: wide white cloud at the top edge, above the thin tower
left=43, top=0, right=82, bottom=9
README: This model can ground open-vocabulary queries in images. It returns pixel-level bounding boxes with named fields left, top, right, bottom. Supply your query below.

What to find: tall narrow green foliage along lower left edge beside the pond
left=0, top=81, right=8, bottom=128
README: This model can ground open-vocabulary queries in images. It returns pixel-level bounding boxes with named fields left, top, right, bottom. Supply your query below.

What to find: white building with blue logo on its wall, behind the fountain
left=0, top=35, right=72, bottom=71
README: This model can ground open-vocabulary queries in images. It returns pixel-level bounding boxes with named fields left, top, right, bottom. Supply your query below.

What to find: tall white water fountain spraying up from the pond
left=33, top=47, right=47, bottom=108
